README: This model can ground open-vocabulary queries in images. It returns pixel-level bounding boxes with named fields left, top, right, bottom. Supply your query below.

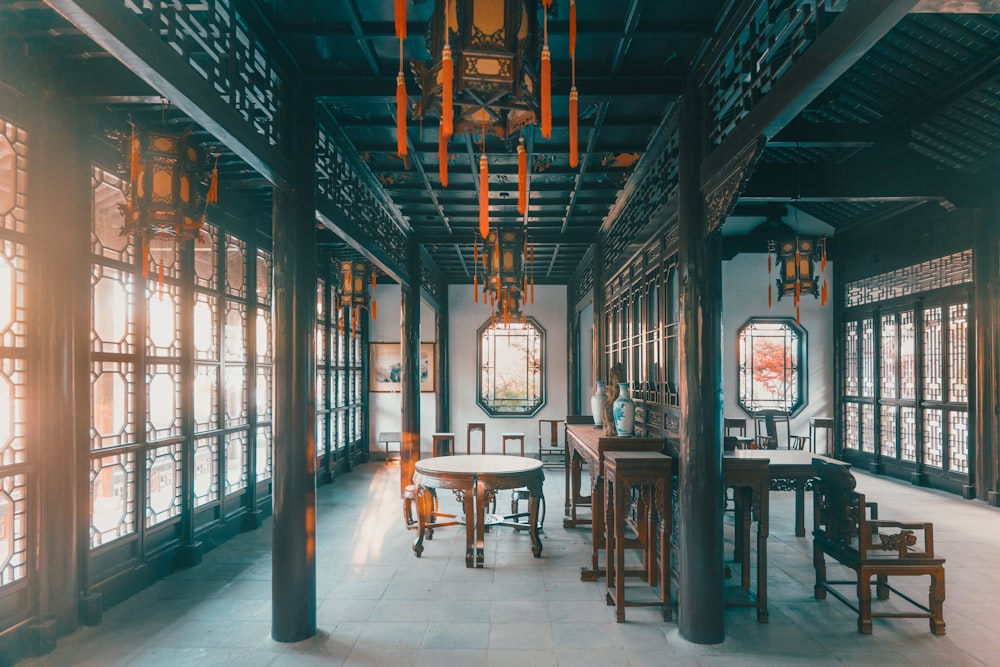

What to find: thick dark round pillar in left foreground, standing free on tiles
left=271, top=96, right=316, bottom=642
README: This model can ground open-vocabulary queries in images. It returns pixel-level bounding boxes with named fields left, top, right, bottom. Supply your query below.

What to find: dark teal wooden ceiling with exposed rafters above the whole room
left=0, top=0, right=1000, bottom=284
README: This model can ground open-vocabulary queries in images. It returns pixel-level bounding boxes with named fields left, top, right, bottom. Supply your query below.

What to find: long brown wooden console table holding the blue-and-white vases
left=563, top=426, right=663, bottom=581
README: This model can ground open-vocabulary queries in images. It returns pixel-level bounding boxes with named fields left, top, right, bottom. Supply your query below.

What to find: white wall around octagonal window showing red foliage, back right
left=722, top=254, right=834, bottom=447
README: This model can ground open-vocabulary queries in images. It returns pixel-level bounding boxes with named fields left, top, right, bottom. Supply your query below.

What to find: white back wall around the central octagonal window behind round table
left=448, top=285, right=568, bottom=453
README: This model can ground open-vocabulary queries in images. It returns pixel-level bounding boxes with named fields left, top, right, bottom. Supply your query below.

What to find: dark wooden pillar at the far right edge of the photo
left=965, top=209, right=1000, bottom=507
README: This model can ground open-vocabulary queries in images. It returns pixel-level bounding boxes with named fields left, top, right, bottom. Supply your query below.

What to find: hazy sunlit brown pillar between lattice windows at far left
left=28, top=98, right=91, bottom=652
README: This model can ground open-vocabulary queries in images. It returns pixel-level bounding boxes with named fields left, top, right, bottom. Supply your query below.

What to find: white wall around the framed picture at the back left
left=368, top=284, right=437, bottom=459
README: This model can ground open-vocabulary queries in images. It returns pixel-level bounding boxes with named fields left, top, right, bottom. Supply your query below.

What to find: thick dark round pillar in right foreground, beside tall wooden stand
left=677, top=89, right=725, bottom=644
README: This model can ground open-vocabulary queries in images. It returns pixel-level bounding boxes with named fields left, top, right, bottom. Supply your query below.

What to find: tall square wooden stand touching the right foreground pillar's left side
left=604, top=451, right=673, bottom=623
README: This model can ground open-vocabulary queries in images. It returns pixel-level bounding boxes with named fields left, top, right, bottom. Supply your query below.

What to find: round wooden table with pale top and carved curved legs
left=413, top=454, right=545, bottom=567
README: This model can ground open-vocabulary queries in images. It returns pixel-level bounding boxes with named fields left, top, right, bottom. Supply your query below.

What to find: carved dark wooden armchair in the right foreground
left=813, top=459, right=945, bottom=635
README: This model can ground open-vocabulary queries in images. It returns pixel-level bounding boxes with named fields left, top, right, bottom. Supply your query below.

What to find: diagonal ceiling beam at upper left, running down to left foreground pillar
left=46, top=0, right=294, bottom=184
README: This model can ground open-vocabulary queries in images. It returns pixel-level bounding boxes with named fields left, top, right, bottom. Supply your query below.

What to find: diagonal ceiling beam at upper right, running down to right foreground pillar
left=701, top=0, right=918, bottom=183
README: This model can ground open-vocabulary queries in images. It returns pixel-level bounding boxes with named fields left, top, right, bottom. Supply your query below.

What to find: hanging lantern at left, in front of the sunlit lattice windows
left=122, top=126, right=218, bottom=275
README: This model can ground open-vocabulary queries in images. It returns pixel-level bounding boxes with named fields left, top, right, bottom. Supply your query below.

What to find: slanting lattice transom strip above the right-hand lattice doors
left=844, top=250, right=972, bottom=308
